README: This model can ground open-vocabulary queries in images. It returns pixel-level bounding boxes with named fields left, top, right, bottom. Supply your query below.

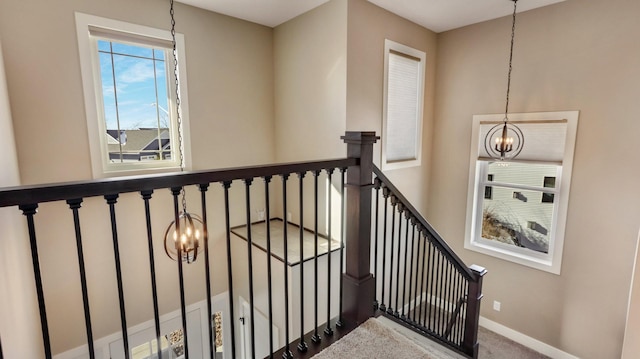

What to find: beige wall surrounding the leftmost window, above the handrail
left=0, top=0, right=275, bottom=184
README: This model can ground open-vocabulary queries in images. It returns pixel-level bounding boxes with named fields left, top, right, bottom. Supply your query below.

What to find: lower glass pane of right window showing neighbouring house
left=482, top=186, right=554, bottom=253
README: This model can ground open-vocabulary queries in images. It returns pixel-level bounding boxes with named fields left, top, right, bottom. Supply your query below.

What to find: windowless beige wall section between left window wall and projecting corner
left=274, top=0, right=347, bottom=162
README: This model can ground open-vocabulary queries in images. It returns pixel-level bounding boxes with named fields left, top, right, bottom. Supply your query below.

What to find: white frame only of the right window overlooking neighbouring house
left=464, top=111, right=579, bottom=275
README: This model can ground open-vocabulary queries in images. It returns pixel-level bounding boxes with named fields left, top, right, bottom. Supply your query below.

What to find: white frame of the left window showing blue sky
left=75, top=12, right=191, bottom=178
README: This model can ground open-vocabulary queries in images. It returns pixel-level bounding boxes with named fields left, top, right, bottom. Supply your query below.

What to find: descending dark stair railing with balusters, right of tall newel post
left=372, top=167, right=486, bottom=358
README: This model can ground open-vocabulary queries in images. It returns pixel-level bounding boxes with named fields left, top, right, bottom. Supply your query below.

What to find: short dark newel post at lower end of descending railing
left=462, top=264, right=487, bottom=358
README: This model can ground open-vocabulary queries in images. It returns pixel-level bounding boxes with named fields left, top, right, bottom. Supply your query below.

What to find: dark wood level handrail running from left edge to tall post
left=0, top=158, right=359, bottom=207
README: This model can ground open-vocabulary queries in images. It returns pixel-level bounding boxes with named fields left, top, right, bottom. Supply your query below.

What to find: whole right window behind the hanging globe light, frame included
left=465, top=111, right=578, bottom=274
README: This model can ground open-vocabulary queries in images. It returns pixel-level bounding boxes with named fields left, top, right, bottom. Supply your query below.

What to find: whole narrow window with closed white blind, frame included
left=382, top=40, right=426, bottom=170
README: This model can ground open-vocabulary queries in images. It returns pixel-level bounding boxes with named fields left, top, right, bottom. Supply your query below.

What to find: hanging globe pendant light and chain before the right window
left=484, top=0, right=524, bottom=161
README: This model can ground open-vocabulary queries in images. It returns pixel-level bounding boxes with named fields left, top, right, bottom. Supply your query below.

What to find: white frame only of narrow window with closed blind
left=380, top=39, right=426, bottom=170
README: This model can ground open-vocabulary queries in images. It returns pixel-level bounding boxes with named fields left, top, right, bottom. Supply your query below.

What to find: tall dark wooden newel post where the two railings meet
left=342, top=131, right=379, bottom=324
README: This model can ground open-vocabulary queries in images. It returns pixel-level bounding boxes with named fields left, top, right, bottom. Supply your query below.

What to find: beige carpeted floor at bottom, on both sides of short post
left=313, top=317, right=548, bottom=359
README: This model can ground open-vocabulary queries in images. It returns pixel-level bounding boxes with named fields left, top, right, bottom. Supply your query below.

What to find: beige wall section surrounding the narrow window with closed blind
left=347, top=0, right=436, bottom=213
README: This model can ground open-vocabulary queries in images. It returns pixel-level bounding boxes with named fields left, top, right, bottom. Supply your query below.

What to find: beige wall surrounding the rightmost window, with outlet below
left=427, top=0, right=640, bottom=358
